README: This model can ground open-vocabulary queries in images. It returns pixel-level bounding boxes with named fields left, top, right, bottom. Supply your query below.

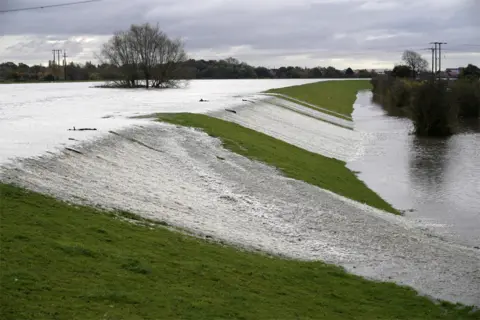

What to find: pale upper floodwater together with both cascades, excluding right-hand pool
left=0, top=80, right=480, bottom=305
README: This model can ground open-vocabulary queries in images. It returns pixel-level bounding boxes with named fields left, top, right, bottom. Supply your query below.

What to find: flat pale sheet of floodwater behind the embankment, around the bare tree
left=0, top=79, right=319, bottom=164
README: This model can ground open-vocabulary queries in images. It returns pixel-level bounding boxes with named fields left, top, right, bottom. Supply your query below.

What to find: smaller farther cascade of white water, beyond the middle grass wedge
left=210, top=97, right=364, bottom=161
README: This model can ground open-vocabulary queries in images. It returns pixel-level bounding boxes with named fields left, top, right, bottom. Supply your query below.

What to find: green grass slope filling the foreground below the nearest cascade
left=0, top=184, right=480, bottom=320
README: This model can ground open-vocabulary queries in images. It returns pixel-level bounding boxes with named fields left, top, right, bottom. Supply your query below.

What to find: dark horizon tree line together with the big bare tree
left=0, top=23, right=376, bottom=88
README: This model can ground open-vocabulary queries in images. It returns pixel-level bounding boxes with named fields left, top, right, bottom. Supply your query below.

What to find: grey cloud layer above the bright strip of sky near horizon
left=0, top=0, right=480, bottom=66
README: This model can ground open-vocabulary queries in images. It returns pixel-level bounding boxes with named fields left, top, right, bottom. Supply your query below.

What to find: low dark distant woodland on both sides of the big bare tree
left=0, top=58, right=376, bottom=82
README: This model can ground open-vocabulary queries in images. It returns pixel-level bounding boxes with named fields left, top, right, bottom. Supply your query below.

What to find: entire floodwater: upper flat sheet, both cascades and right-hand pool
left=0, top=80, right=480, bottom=305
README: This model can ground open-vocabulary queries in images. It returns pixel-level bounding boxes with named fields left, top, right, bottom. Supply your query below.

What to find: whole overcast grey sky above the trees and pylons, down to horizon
left=0, top=0, right=480, bottom=68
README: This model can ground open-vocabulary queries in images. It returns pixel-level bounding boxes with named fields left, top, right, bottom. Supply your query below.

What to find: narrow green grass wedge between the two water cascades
left=159, top=113, right=399, bottom=214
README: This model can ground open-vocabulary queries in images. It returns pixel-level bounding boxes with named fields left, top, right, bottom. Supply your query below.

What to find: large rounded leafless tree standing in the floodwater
left=99, top=23, right=187, bottom=89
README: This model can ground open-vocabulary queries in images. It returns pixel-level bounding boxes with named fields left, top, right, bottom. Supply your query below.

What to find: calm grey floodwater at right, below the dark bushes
left=348, top=93, right=480, bottom=246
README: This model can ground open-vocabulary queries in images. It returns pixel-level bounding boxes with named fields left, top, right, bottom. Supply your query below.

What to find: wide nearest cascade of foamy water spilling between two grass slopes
left=0, top=123, right=480, bottom=305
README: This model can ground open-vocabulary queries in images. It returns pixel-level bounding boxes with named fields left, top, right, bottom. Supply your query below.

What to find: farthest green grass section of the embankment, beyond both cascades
left=267, top=80, right=372, bottom=116
